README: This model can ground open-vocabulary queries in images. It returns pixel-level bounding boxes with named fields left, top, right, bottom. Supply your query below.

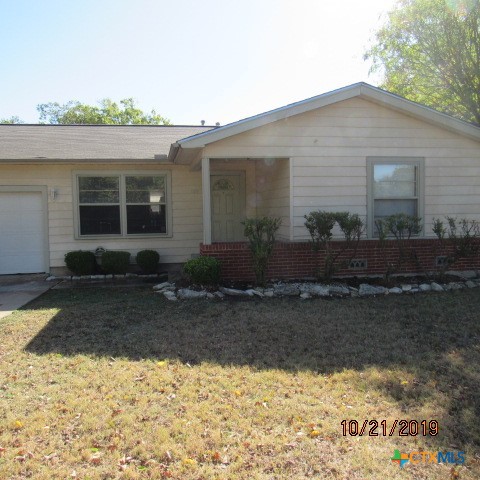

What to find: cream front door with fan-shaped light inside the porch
left=210, top=174, right=245, bottom=242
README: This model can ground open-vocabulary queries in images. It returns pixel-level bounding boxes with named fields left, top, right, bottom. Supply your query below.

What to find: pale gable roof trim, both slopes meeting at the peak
left=178, top=82, right=480, bottom=148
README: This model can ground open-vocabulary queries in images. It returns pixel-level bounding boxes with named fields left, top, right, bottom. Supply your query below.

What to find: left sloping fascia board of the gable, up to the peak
left=177, top=83, right=361, bottom=148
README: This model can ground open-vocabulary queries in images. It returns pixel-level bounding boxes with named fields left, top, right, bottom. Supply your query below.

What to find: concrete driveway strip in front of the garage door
left=0, top=274, right=56, bottom=318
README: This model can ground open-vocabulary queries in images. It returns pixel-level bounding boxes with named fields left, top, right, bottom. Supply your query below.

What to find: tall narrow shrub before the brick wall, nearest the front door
left=242, top=217, right=282, bottom=286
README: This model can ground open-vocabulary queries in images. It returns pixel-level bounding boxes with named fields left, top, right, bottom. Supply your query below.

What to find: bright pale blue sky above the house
left=0, top=0, right=394, bottom=125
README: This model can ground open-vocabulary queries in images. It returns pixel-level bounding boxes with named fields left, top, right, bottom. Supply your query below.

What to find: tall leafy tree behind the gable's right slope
left=365, top=0, right=480, bottom=123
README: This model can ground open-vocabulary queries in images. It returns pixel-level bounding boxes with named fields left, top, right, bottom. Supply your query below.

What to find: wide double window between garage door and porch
left=76, top=173, right=169, bottom=237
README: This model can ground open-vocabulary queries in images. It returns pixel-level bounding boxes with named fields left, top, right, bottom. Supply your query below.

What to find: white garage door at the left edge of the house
left=0, top=192, right=46, bottom=274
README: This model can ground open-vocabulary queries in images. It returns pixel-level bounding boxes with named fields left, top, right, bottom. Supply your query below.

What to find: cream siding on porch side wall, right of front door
left=255, top=159, right=290, bottom=240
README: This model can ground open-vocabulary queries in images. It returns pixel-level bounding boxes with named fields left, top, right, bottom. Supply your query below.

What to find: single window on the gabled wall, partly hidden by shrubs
left=367, top=157, right=424, bottom=237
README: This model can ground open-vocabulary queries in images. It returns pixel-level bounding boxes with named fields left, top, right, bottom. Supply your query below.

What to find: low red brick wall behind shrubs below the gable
left=200, top=239, right=480, bottom=281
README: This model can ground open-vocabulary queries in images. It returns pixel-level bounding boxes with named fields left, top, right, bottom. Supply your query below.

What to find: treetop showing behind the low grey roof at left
left=37, top=98, right=170, bottom=125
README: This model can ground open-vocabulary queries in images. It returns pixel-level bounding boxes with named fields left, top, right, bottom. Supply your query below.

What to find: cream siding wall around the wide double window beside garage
left=0, top=164, right=203, bottom=267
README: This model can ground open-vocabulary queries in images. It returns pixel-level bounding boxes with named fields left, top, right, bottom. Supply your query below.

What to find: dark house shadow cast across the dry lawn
left=26, top=284, right=480, bottom=446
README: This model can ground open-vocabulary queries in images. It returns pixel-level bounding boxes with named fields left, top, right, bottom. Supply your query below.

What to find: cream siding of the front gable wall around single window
left=204, top=98, right=480, bottom=240
